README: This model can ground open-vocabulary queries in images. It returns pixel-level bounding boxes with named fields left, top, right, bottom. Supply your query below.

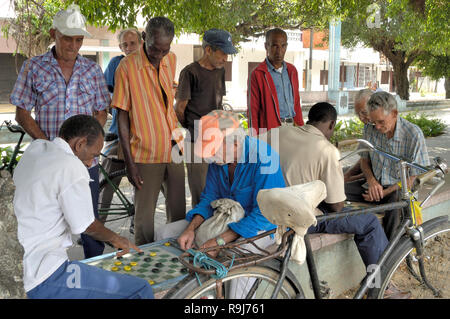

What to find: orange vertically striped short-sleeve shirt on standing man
left=111, top=46, right=178, bottom=163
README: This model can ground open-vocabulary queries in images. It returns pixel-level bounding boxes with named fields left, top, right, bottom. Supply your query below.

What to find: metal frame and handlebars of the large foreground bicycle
left=305, top=139, right=446, bottom=299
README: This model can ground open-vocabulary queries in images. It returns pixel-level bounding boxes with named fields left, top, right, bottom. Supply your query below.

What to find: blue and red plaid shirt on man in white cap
left=10, top=47, right=111, bottom=140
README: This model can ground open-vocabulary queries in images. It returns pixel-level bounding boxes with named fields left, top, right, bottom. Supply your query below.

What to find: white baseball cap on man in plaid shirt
left=53, top=4, right=92, bottom=38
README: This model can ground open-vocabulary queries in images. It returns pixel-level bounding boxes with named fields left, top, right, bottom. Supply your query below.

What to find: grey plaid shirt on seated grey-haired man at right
left=361, top=116, right=430, bottom=186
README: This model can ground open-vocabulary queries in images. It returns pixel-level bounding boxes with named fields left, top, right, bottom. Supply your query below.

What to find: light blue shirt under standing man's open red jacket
left=266, top=58, right=295, bottom=119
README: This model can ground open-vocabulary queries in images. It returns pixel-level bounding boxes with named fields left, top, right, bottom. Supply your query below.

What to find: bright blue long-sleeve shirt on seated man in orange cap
left=186, top=136, right=286, bottom=238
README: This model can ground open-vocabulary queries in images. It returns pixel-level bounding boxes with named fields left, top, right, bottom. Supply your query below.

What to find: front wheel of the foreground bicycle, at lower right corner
left=369, top=216, right=450, bottom=299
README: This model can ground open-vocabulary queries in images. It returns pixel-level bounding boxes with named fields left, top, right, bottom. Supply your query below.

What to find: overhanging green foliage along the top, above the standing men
left=72, top=0, right=340, bottom=43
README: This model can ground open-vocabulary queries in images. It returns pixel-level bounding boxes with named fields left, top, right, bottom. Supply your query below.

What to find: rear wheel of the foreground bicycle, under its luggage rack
left=164, top=260, right=304, bottom=299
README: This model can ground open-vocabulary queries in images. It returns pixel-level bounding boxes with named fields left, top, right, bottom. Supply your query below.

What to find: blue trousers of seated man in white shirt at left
left=27, top=260, right=154, bottom=299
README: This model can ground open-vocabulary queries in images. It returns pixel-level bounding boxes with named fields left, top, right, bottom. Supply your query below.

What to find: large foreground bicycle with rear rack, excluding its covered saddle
left=164, top=139, right=450, bottom=299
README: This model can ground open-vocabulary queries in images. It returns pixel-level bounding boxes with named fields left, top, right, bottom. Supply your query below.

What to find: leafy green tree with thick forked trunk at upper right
left=342, top=0, right=450, bottom=100
